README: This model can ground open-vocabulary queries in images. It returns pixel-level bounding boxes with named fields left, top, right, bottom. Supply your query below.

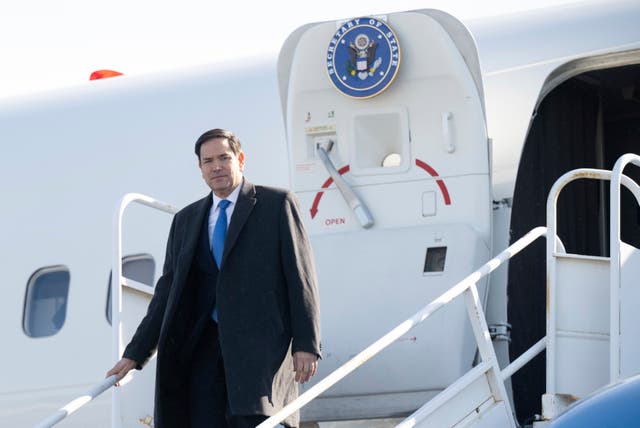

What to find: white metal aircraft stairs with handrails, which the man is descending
left=37, top=154, right=640, bottom=428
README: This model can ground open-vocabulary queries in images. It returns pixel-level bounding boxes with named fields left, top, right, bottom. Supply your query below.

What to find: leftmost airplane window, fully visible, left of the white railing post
left=22, top=266, right=71, bottom=337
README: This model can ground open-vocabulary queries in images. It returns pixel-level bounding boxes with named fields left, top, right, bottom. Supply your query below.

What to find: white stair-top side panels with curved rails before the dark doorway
left=542, top=154, right=640, bottom=420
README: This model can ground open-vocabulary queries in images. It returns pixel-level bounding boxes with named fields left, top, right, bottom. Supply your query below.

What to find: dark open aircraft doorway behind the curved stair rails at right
left=507, top=60, right=640, bottom=422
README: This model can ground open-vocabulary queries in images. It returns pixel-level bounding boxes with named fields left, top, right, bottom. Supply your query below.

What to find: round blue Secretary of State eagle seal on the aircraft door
left=327, top=18, right=400, bottom=98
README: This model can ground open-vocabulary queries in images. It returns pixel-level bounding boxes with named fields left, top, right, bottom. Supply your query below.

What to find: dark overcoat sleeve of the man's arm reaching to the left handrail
left=123, top=217, right=176, bottom=370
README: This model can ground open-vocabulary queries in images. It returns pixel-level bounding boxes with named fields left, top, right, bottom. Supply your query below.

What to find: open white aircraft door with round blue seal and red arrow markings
left=278, top=10, right=491, bottom=420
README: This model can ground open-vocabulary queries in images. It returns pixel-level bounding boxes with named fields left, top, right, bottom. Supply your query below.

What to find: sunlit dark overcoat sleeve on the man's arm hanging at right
left=279, top=192, right=321, bottom=357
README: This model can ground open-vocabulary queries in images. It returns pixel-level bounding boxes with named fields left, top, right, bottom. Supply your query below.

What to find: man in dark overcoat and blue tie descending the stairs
left=107, top=129, right=320, bottom=428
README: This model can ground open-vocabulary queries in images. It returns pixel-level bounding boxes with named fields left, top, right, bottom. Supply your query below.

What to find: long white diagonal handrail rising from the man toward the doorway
left=256, top=226, right=547, bottom=428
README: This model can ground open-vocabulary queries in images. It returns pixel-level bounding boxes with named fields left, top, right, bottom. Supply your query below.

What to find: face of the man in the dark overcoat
left=198, top=137, right=244, bottom=199
